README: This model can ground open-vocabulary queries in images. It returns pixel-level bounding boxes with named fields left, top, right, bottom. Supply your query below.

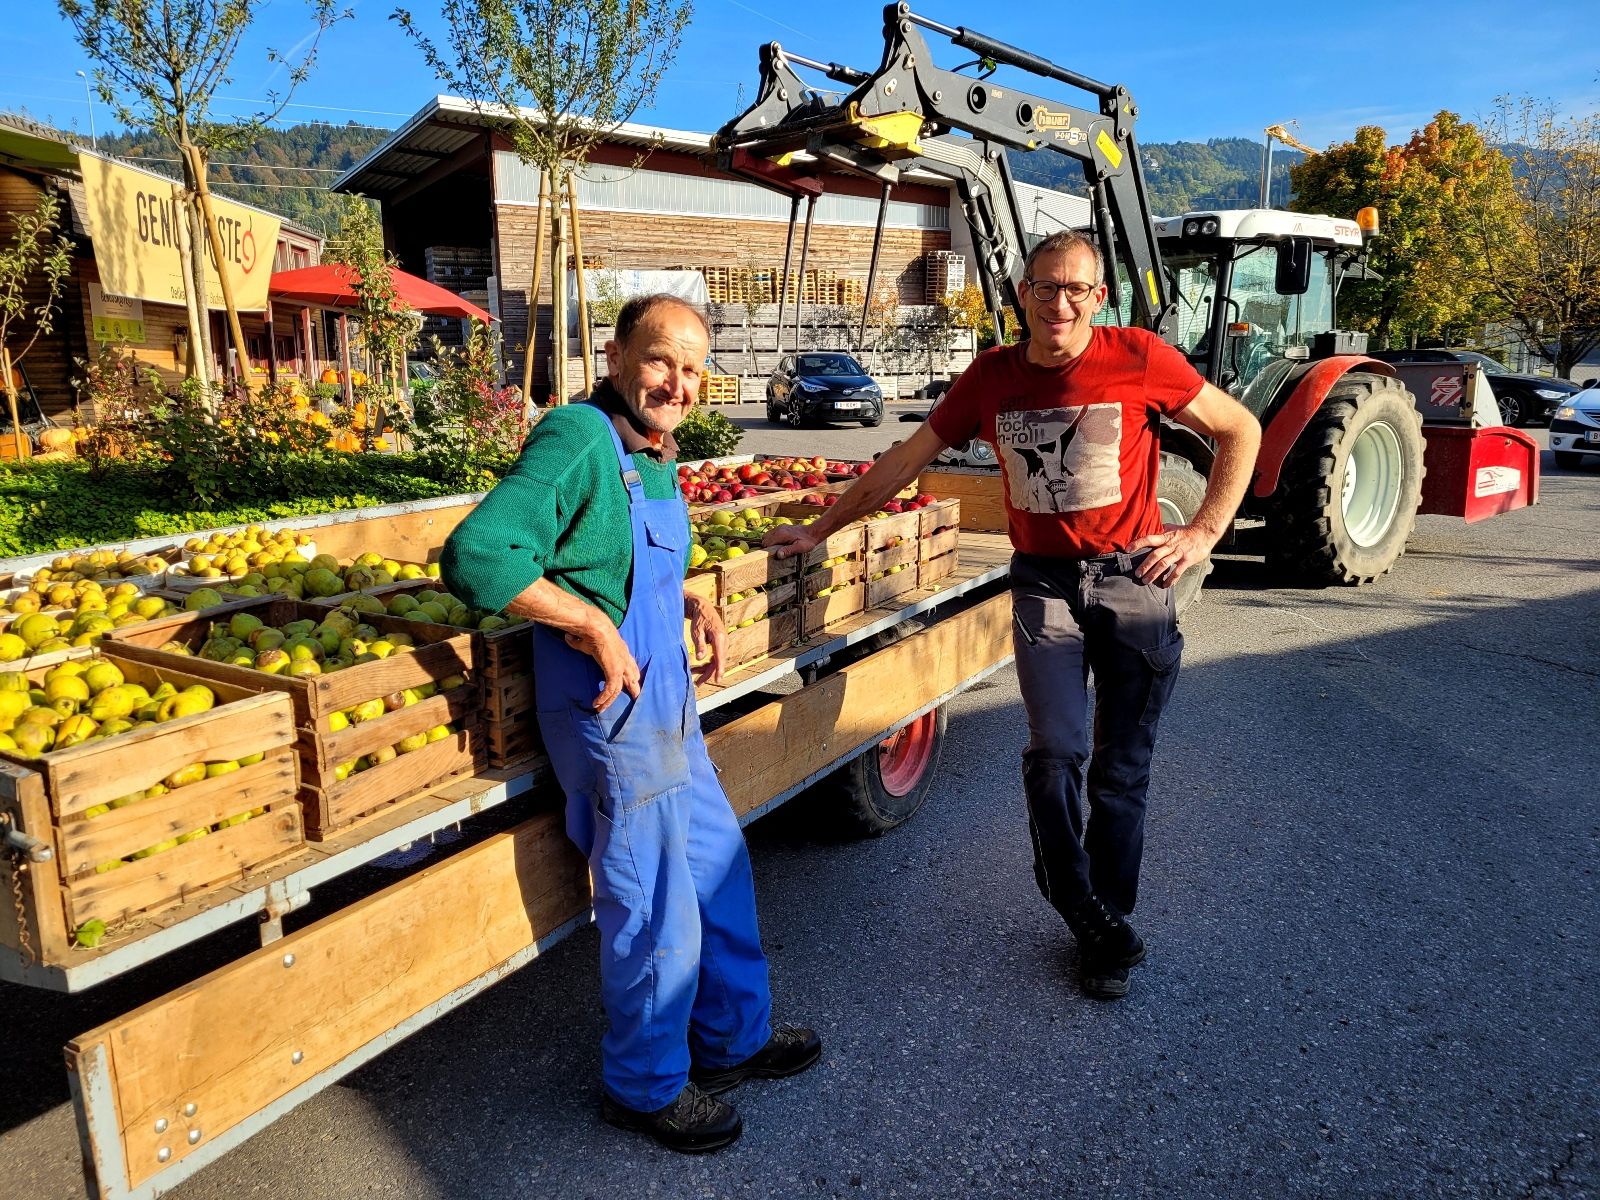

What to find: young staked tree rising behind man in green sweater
left=394, top=0, right=693, bottom=403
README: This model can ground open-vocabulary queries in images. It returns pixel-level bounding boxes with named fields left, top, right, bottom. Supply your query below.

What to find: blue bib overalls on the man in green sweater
left=534, top=410, right=771, bottom=1112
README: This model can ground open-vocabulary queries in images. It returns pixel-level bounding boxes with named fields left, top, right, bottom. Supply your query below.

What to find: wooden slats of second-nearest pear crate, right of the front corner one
left=112, top=597, right=485, bottom=842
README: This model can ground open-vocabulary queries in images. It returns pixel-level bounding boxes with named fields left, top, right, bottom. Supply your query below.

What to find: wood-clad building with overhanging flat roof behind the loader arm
left=334, top=96, right=971, bottom=400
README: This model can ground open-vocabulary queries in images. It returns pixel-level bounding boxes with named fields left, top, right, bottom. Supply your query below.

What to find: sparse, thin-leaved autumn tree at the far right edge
left=1467, top=96, right=1600, bottom=379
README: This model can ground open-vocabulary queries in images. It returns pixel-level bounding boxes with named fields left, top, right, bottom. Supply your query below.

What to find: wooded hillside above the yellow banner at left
left=99, top=123, right=389, bottom=234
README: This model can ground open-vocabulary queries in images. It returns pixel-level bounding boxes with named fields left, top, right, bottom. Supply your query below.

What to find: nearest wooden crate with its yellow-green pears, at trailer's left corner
left=0, top=648, right=304, bottom=955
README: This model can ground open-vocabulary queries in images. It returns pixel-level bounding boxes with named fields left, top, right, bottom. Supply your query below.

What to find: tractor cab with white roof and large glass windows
left=1154, top=208, right=1376, bottom=416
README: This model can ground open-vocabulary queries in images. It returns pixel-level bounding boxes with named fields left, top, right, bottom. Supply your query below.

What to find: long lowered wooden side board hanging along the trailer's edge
left=67, top=595, right=1011, bottom=1200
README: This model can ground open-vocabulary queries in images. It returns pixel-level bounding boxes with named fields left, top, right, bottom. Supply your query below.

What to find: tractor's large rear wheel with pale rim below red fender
left=1267, top=371, right=1424, bottom=587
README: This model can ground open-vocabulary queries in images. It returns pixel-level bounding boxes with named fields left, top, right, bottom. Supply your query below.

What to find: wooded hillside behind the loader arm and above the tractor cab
left=1010, top=138, right=1306, bottom=216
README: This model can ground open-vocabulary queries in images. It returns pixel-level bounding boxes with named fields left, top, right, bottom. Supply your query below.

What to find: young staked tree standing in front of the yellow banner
left=56, top=0, right=350, bottom=379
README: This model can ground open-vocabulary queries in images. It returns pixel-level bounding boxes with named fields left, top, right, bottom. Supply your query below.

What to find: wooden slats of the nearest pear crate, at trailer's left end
left=0, top=646, right=306, bottom=940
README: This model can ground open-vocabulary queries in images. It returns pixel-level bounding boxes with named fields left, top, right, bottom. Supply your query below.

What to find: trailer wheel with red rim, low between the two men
left=814, top=621, right=949, bottom=837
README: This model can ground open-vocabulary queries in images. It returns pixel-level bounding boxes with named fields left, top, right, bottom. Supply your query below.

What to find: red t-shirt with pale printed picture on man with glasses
left=928, top=325, right=1205, bottom=558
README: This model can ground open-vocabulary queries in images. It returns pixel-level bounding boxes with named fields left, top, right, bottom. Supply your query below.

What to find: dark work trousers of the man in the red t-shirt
left=1011, top=552, right=1184, bottom=915
